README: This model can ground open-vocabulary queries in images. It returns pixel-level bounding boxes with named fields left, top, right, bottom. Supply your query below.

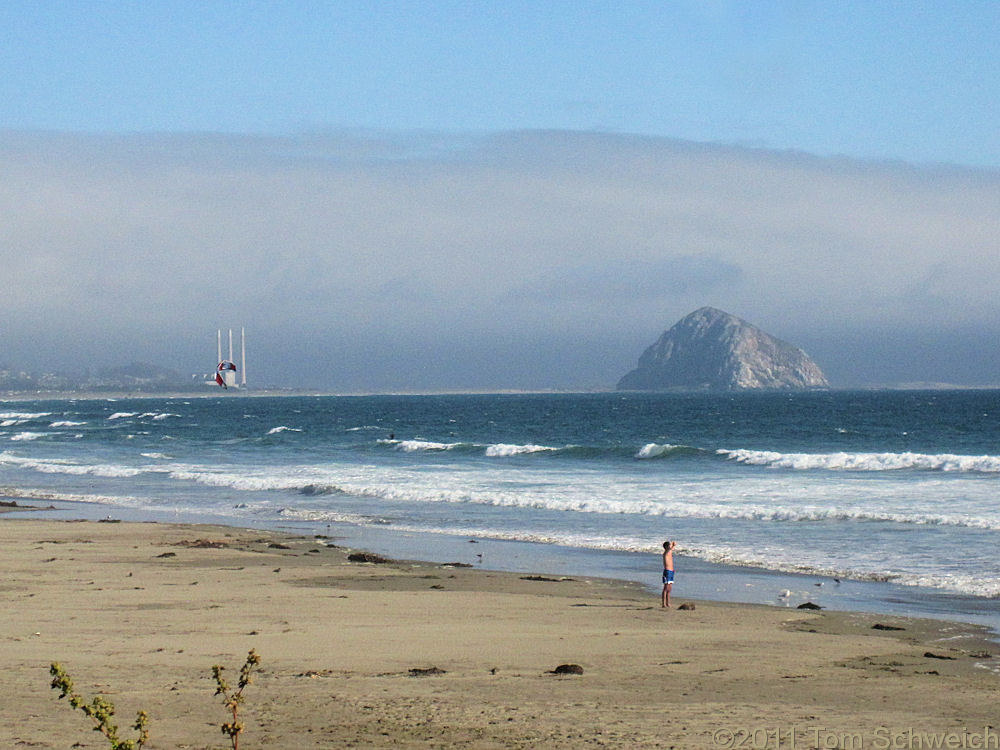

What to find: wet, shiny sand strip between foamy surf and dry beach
left=9, top=502, right=1000, bottom=640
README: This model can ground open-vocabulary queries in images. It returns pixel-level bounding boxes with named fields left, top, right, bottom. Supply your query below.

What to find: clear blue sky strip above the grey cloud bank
left=0, top=0, right=1000, bottom=166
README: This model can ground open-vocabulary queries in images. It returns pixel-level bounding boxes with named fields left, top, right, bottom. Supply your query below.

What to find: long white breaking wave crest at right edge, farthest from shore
left=717, top=449, right=1000, bottom=473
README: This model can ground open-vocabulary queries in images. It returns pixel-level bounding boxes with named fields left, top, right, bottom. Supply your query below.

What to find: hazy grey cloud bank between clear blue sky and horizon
left=0, top=132, right=1000, bottom=390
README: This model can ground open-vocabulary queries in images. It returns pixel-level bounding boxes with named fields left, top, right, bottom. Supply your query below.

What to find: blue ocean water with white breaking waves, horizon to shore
left=0, top=391, right=1000, bottom=628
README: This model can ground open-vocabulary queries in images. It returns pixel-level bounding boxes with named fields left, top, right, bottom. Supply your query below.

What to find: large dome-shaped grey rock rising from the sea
left=618, top=307, right=829, bottom=391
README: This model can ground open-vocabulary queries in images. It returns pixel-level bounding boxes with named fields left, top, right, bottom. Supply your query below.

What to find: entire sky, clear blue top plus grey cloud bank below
left=0, top=5, right=1000, bottom=391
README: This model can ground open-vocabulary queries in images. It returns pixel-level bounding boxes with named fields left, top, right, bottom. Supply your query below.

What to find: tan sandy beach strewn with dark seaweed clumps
left=0, top=516, right=1000, bottom=748
